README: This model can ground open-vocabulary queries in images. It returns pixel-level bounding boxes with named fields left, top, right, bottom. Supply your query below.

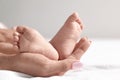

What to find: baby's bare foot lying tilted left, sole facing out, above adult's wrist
left=14, top=26, right=58, bottom=60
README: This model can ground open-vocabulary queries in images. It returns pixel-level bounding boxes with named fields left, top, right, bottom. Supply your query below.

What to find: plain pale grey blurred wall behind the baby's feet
left=0, top=0, right=120, bottom=38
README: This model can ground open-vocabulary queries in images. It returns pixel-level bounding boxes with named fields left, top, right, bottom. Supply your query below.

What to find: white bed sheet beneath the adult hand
left=0, top=39, right=120, bottom=80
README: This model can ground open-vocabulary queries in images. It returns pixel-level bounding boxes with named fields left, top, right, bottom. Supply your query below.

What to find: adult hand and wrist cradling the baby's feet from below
left=0, top=37, right=90, bottom=76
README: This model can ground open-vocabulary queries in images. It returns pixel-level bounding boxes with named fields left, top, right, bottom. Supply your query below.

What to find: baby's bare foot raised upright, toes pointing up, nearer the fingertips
left=50, top=13, right=83, bottom=59
